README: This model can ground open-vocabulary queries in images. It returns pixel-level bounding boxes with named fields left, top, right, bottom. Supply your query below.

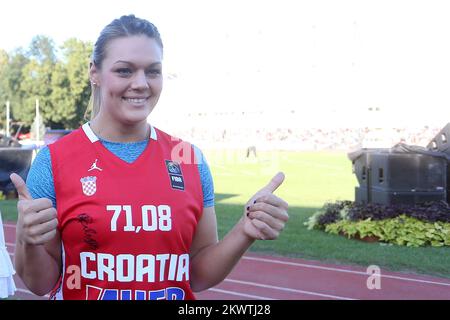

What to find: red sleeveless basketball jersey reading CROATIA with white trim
left=49, top=124, right=203, bottom=300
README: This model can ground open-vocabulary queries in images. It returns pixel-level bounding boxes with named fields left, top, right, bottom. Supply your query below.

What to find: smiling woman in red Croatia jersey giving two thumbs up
left=11, top=15, right=288, bottom=300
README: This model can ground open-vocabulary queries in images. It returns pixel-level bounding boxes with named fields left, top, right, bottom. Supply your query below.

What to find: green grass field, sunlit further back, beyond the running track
left=0, top=150, right=450, bottom=278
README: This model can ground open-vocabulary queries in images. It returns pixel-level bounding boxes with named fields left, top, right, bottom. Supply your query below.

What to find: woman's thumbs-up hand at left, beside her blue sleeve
left=10, top=173, right=58, bottom=245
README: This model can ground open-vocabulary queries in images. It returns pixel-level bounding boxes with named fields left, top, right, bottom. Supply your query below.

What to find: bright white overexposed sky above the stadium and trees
left=0, top=0, right=450, bottom=125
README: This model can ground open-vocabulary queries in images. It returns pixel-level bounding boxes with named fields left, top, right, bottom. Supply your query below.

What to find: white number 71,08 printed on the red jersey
left=106, top=204, right=172, bottom=232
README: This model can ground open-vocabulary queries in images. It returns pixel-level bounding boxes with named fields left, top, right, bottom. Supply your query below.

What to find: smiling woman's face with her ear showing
left=91, top=35, right=163, bottom=125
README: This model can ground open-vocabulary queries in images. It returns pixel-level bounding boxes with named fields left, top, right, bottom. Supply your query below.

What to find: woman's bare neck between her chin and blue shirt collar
left=89, top=117, right=150, bottom=142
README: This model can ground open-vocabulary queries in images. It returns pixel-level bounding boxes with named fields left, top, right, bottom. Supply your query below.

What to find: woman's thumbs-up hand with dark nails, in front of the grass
left=244, top=172, right=289, bottom=240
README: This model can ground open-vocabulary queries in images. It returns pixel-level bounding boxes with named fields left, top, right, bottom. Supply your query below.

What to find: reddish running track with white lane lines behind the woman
left=4, top=223, right=450, bottom=300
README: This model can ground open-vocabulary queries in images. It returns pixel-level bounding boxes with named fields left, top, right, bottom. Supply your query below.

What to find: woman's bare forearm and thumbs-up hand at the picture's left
left=11, top=174, right=61, bottom=295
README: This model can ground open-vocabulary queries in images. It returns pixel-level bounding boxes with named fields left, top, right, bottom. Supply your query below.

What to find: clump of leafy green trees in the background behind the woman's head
left=0, top=35, right=93, bottom=129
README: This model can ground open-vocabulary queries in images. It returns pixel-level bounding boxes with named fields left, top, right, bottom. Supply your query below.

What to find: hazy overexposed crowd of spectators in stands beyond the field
left=165, top=124, right=442, bottom=151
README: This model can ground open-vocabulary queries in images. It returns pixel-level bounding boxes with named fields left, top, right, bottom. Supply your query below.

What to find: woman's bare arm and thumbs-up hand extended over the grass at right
left=191, top=175, right=288, bottom=291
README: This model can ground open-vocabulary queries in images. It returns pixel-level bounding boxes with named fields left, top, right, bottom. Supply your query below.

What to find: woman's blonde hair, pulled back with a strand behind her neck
left=84, top=14, right=163, bottom=120
